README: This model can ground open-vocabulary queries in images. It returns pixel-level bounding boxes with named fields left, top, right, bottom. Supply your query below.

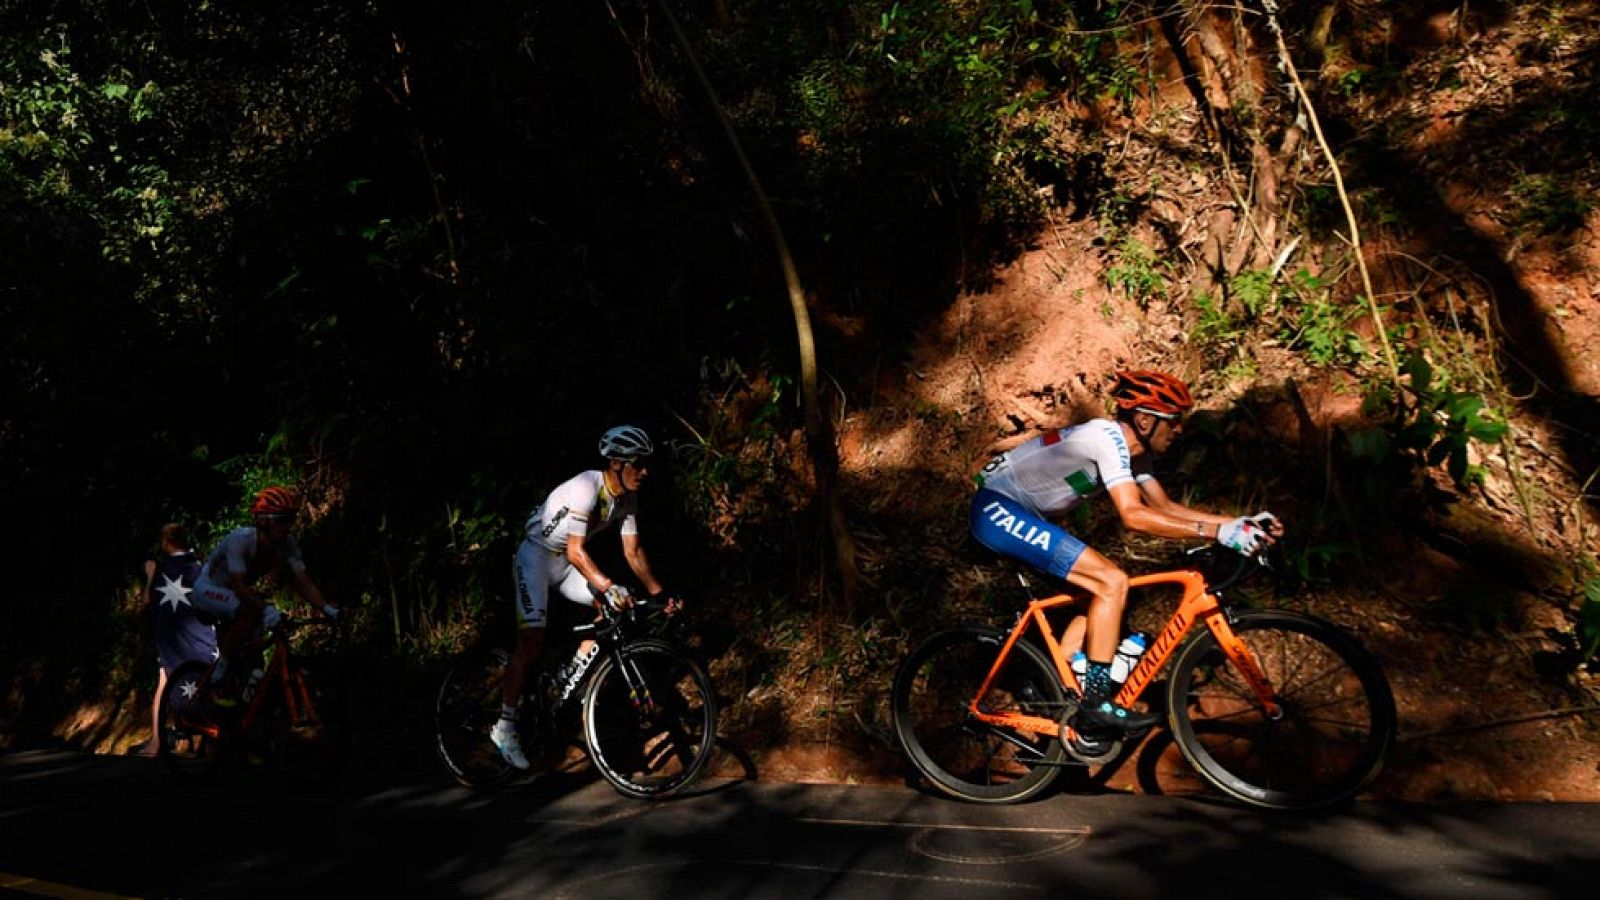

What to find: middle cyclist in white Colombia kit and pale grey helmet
left=490, top=424, right=682, bottom=769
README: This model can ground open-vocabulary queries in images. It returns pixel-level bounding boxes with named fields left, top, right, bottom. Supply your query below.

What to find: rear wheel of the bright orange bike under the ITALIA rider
left=890, top=628, right=1066, bottom=804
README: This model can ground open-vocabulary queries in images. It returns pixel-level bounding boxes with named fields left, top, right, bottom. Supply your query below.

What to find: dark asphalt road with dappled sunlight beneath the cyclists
left=0, top=751, right=1600, bottom=900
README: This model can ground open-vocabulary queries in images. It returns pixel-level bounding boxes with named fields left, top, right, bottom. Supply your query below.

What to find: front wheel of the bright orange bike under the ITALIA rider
left=1166, top=610, right=1397, bottom=810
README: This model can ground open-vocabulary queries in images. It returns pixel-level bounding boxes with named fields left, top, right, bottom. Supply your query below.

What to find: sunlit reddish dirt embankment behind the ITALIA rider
left=784, top=5, right=1600, bottom=801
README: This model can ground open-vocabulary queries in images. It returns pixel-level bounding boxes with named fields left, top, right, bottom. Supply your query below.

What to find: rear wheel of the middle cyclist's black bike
left=434, top=647, right=515, bottom=788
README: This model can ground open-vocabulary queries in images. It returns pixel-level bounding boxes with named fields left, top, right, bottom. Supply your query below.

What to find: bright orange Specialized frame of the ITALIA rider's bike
left=968, top=570, right=1280, bottom=738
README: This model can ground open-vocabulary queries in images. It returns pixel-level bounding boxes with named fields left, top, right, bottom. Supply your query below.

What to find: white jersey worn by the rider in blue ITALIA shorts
left=978, top=418, right=1154, bottom=519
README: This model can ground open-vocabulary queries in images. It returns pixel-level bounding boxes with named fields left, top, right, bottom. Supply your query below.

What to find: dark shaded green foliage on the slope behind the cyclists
left=0, top=0, right=1600, bottom=743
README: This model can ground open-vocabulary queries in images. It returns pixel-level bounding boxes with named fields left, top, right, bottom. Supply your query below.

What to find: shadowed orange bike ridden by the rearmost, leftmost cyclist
left=155, top=617, right=349, bottom=785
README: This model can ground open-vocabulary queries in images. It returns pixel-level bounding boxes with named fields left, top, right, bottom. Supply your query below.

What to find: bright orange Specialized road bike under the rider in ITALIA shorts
left=893, top=548, right=1395, bottom=809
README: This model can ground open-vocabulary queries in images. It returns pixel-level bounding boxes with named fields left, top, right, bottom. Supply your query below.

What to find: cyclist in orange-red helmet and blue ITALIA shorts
left=970, top=372, right=1283, bottom=733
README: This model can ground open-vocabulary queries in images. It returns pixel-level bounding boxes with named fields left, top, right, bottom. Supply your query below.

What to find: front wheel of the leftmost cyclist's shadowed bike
left=262, top=666, right=350, bottom=786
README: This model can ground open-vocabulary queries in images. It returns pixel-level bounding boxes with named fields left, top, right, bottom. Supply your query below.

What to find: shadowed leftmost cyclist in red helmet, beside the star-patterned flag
left=194, top=487, right=339, bottom=681
